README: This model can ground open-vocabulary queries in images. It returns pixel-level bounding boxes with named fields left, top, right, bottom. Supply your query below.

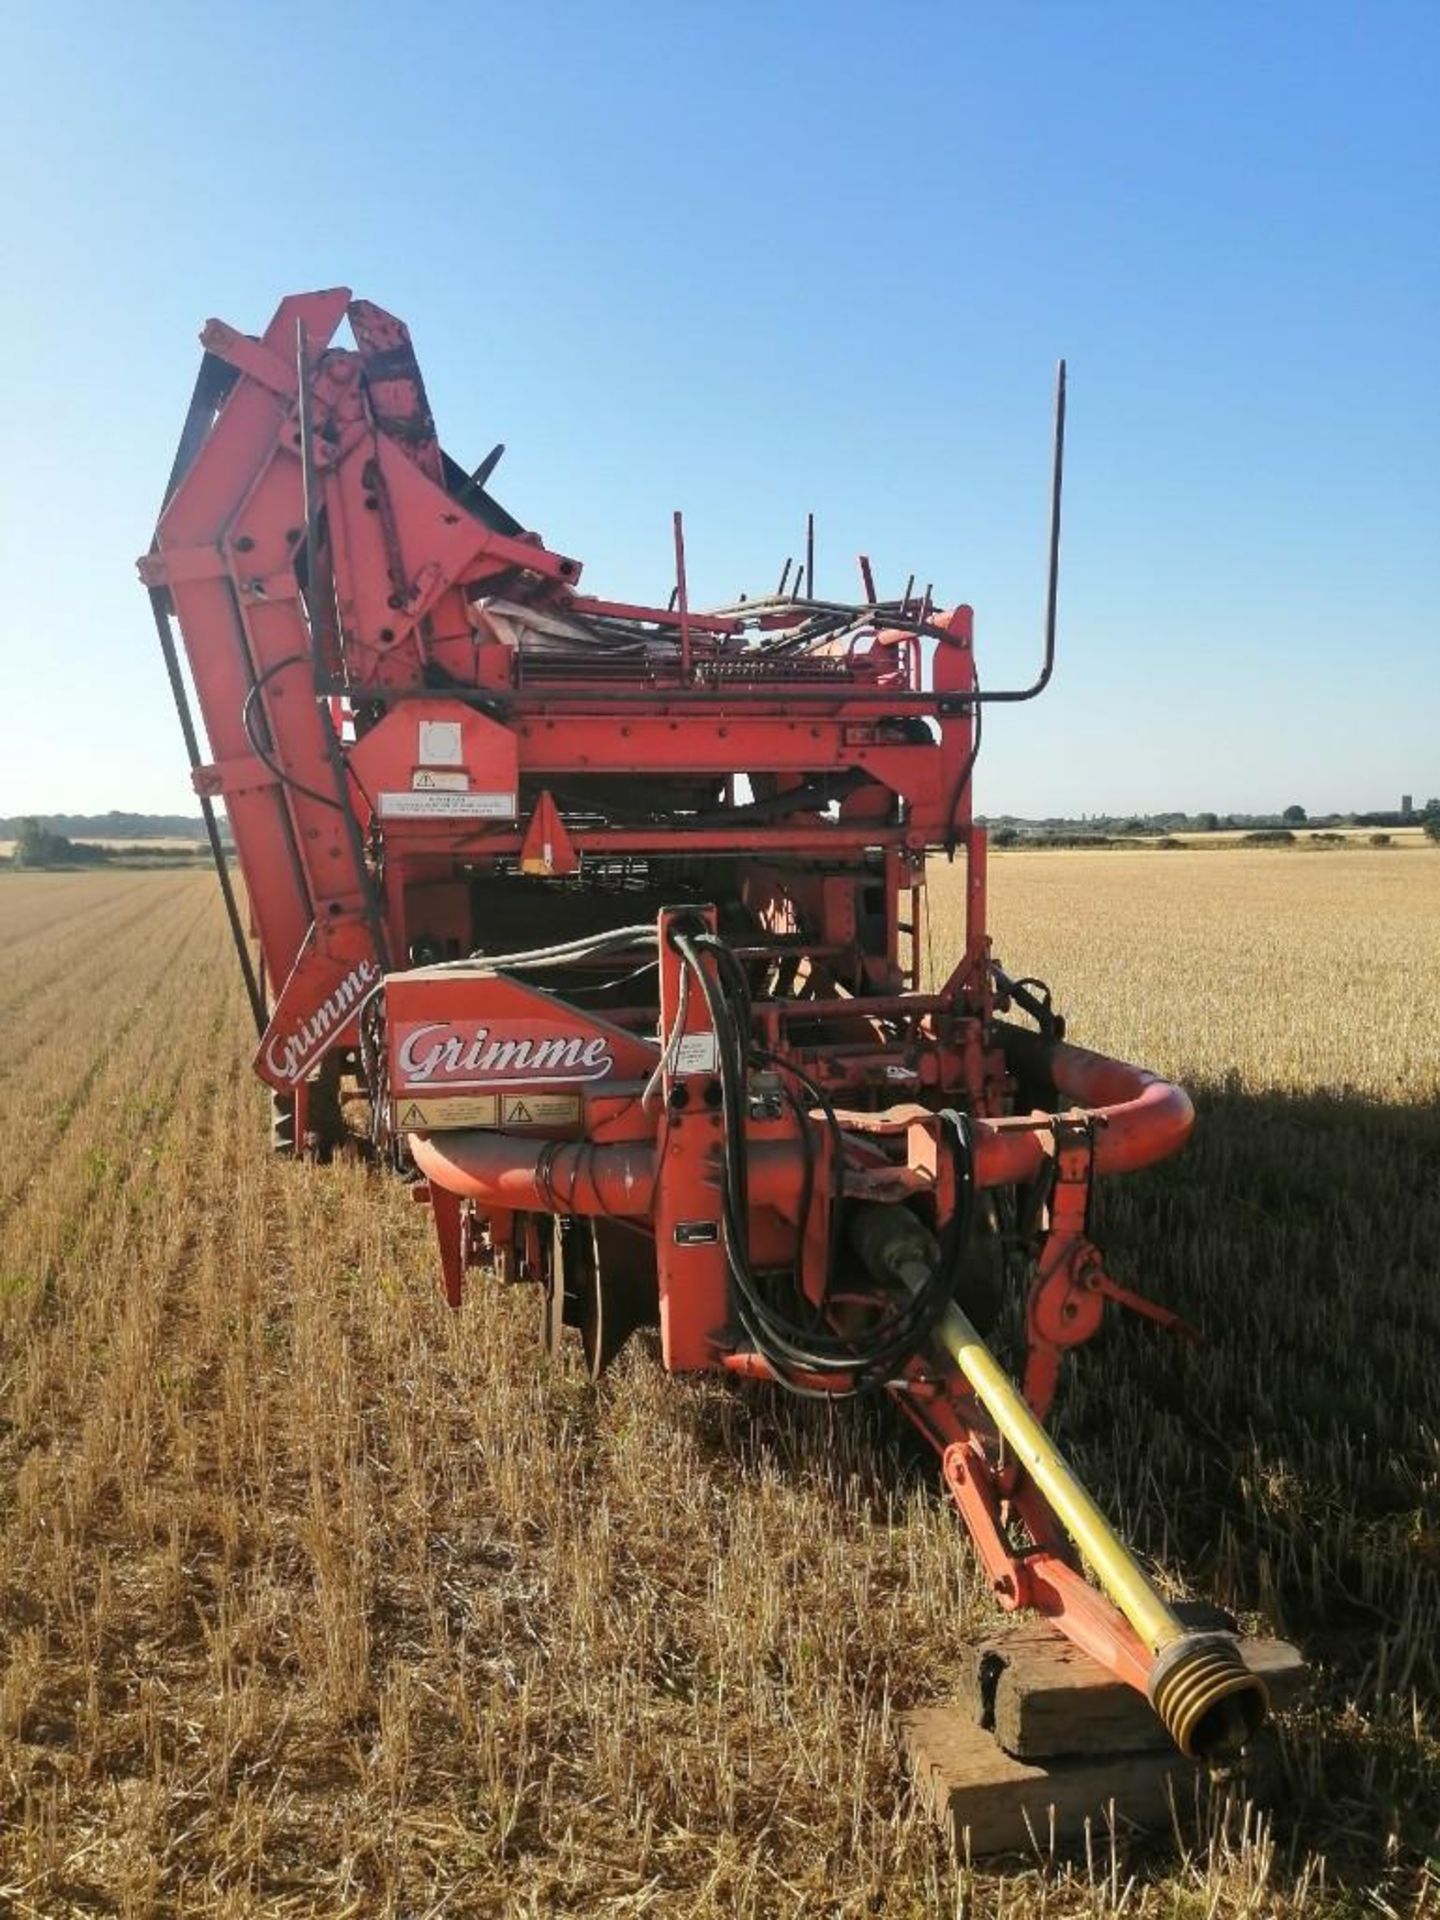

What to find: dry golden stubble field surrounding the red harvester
left=0, top=852, right=1440, bottom=1920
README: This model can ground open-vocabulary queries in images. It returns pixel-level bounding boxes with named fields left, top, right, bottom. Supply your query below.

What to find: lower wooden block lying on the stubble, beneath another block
left=900, top=1707, right=1275, bottom=1859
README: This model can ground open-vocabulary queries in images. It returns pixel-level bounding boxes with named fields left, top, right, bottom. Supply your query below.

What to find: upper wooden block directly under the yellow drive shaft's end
left=964, top=1628, right=1309, bottom=1761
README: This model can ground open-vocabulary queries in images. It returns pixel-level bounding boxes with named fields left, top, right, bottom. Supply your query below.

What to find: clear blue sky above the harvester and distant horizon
left=0, top=0, right=1440, bottom=814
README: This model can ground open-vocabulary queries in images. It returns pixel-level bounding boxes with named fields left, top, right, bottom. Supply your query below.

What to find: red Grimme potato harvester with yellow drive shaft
left=140, top=288, right=1267, bottom=1759
